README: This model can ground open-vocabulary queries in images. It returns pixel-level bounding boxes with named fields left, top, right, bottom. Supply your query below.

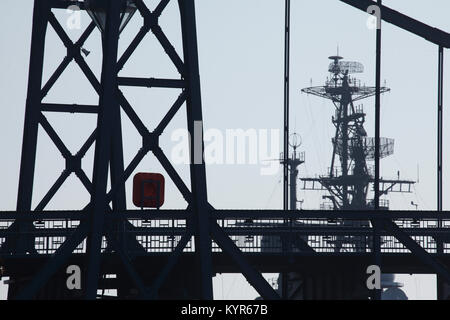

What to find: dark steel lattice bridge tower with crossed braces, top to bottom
left=1, top=0, right=213, bottom=299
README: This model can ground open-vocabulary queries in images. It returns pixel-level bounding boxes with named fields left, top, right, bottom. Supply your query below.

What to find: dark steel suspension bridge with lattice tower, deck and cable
left=0, top=0, right=450, bottom=299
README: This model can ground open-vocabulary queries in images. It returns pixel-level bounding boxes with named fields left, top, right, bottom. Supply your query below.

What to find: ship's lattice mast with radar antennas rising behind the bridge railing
left=301, top=56, right=414, bottom=210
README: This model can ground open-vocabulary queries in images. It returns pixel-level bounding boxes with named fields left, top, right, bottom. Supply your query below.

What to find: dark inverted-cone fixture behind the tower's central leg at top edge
left=86, top=0, right=137, bottom=33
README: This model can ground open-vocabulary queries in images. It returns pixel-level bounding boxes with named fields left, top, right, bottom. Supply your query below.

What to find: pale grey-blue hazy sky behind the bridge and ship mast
left=0, top=0, right=450, bottom=298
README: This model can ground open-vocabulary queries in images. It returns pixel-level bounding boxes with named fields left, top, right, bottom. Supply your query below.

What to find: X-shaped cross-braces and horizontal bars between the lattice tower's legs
left=35, top=0, right=190, bottom=211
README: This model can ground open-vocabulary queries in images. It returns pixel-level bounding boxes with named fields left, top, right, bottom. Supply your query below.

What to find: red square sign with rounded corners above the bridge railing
left=133, top=172, right=164, bottom=208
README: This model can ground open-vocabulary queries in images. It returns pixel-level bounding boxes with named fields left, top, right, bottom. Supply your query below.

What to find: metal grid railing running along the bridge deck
left=0, top=211, right=450, bottom=255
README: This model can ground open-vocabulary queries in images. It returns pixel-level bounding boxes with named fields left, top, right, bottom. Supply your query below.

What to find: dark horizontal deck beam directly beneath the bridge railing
left=4, top=252, right=450, bottom=276
